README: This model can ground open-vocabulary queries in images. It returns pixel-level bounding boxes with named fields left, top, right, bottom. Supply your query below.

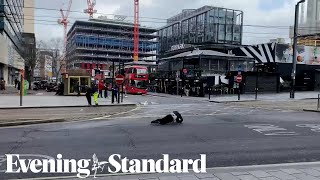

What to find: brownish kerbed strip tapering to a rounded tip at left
left=0, top=104, right=137, bottom=127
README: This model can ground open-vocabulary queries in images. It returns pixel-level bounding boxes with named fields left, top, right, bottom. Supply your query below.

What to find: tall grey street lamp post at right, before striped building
left=290, top=0, right=306, bottom=99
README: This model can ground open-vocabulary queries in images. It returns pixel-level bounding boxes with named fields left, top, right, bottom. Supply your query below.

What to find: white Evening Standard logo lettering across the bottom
left=5, top=154, right=206, bottom=178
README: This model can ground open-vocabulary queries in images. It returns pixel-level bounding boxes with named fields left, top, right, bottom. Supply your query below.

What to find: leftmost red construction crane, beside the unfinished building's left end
left=58, top=0, right=72, bottom=73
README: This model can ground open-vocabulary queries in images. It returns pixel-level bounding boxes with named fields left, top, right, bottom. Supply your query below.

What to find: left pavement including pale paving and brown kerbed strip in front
left=0, top=91, right=136, bottom=127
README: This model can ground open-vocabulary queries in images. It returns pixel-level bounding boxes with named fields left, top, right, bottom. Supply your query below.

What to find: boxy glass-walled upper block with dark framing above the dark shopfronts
left=158, top=6, right=243, bottom=53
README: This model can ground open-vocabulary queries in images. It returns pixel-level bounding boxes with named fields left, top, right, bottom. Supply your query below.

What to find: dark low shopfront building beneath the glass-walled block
left=158, top=50, right=255, bottom=97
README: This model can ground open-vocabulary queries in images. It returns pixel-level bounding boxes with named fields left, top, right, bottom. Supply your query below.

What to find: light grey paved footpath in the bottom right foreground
left=61, top=162, right=320, bottom=180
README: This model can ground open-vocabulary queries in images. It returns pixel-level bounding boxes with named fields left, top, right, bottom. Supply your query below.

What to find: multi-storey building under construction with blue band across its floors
left=67, top=17, right=157, bottom=70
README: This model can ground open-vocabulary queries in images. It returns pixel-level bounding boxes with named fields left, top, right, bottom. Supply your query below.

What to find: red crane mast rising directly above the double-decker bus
left=133, top=0, right=139, bottom=62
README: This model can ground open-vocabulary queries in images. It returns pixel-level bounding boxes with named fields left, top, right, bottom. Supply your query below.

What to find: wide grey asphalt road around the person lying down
left=0, top=96, right=320, bottom=179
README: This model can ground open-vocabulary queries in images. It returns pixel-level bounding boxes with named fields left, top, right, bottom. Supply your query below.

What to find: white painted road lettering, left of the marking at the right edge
left=244, top=124, right=299, bottom=136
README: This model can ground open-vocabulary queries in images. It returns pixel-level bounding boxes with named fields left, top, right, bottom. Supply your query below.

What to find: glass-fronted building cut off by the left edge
left=0, top=0, right=24, bottom=84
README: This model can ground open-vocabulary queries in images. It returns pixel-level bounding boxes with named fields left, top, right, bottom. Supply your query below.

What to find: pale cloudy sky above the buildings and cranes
left=35, top=0, right=298, bottom=44
